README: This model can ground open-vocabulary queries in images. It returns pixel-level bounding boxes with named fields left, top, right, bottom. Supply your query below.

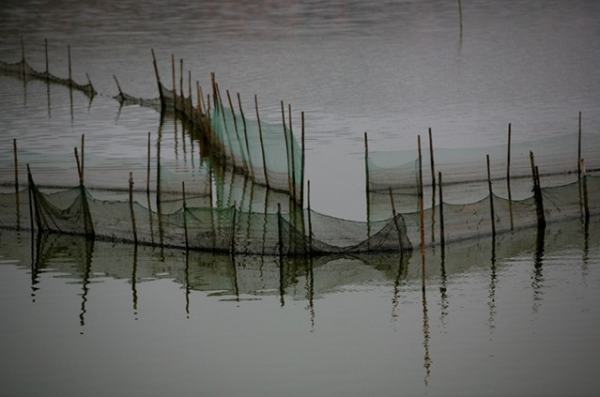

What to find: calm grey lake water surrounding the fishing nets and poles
left=0, top=0, right=600, bottom=396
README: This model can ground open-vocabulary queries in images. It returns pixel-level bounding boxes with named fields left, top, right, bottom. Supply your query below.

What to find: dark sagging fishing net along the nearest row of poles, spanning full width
left=0, top=172, right=600, bottom=256
